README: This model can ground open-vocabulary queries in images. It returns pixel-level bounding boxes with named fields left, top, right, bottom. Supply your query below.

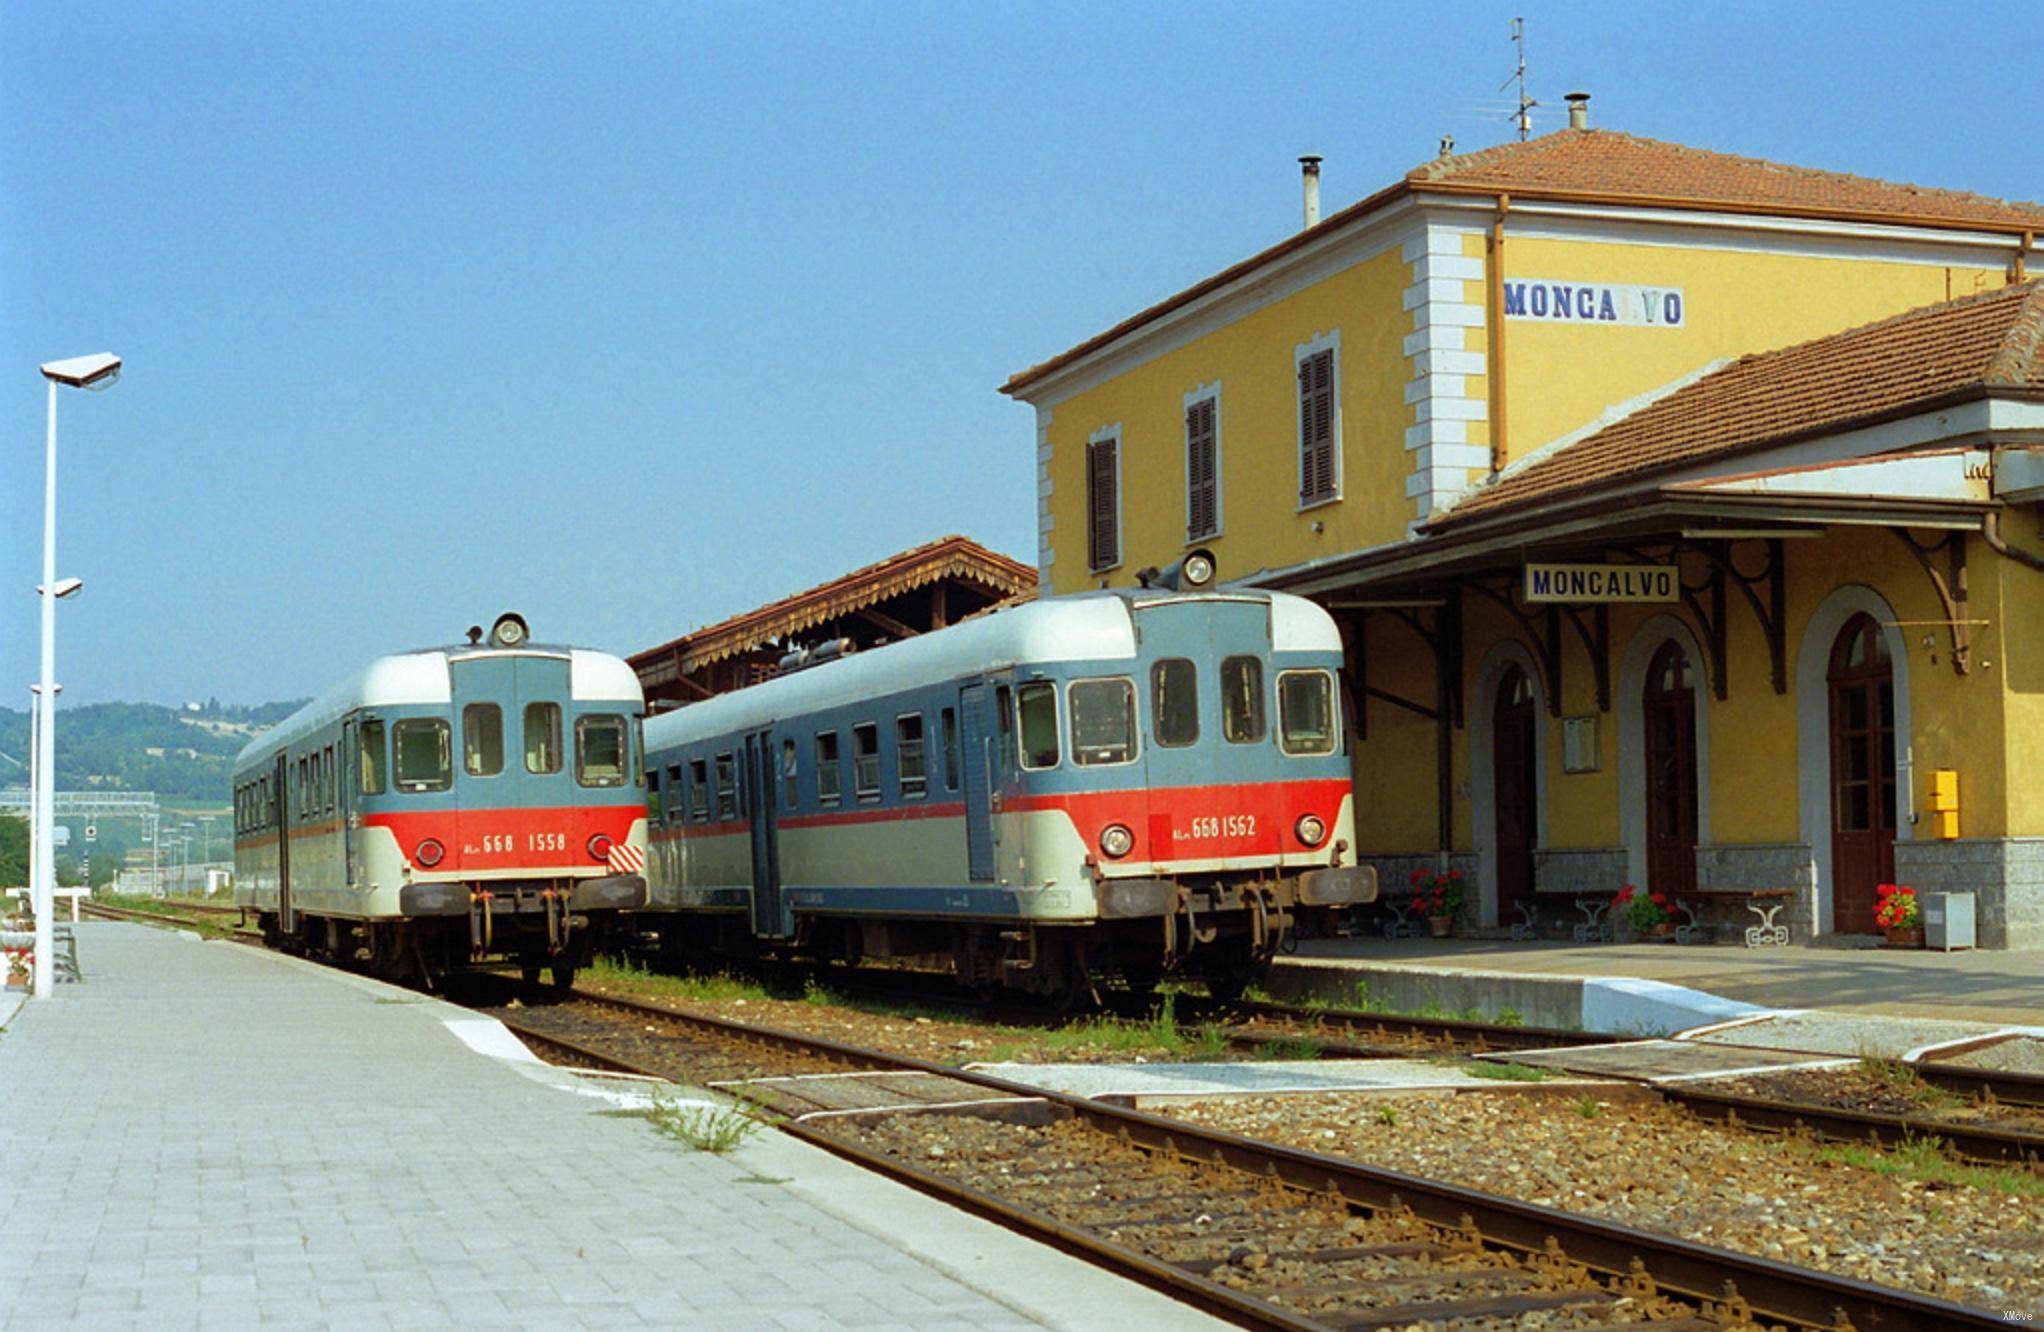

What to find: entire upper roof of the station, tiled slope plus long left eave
left=1002, top=129, right=2044, bottom=394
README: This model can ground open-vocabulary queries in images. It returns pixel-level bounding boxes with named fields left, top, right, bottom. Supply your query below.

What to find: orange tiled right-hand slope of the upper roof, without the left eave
left=1406, top=129, right=2044, bottom=229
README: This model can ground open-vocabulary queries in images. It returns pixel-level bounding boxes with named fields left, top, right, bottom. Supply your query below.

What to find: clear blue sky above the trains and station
left=0, top=2, right=2044, bottom=707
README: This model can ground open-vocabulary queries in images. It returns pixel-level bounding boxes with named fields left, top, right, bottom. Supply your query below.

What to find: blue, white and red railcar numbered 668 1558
left=233, top=615, right=646, bottom=987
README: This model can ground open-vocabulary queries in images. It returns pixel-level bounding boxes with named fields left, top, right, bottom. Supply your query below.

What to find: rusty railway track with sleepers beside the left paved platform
left=486, top=976, right=2001, bottom=1332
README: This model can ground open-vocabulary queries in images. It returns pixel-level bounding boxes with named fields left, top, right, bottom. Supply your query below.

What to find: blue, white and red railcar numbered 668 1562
left=646, top=584, right=1376, bottom=1001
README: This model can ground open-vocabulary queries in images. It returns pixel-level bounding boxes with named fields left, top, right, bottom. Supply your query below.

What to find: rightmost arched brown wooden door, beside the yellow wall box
left=1827, top=613, right=1895, bottom=934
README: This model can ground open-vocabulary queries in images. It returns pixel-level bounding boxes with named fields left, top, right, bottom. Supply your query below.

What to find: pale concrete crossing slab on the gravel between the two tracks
left=971, top=1058, right=1618, bottom=1107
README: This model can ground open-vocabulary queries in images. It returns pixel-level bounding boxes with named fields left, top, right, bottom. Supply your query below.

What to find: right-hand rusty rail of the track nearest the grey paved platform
left=535, top=991, right=2007, bottom=1332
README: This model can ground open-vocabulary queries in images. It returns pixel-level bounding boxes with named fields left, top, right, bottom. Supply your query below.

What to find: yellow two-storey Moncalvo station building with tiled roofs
left=1004, top=100, right=2044, bottom=948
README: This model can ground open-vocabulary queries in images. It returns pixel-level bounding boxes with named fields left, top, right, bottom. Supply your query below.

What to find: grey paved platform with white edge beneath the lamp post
left=0, top=923, right=1216, bottom=1330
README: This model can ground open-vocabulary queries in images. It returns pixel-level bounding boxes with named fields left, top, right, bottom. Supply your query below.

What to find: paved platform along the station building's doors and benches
left=1278, top=940, right=2044, bottom=1026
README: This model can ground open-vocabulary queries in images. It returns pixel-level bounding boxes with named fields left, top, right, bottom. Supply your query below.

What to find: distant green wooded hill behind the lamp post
left=0, top=699, right=305, bottom=803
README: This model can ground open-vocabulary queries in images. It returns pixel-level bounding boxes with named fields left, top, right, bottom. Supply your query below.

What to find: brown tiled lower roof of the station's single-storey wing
left=1429, top=282, right=2044, bottom=527
